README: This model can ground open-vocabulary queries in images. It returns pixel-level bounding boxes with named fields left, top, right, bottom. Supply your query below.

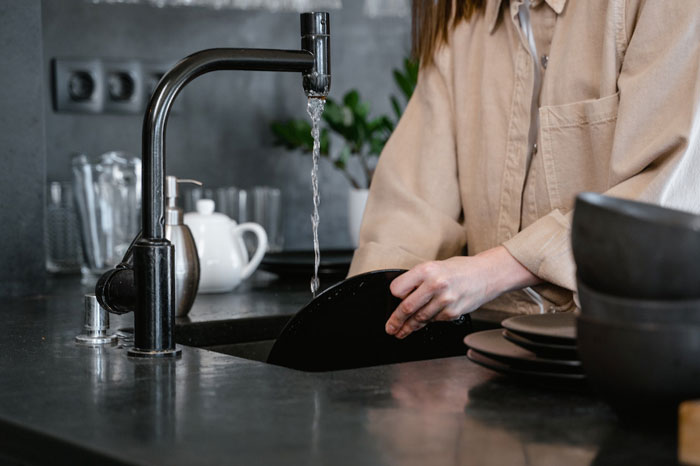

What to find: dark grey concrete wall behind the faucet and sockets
left=43, top=0, right=410, bottom=249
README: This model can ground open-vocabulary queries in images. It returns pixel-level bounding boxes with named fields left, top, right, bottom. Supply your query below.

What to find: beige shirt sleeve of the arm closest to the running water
left=349, top=48, right=466, bottom=275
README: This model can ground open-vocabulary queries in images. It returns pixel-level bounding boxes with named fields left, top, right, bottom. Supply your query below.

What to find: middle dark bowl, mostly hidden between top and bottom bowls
left=578, top=278, right=700, bottom=325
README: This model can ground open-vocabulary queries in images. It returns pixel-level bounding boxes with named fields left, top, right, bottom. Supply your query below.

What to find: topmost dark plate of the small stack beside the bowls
left=501, top=312, right=576, bottom=346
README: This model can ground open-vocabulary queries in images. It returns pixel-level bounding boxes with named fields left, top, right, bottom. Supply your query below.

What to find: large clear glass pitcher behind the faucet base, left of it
left=72, top=152, right=141, bottom=276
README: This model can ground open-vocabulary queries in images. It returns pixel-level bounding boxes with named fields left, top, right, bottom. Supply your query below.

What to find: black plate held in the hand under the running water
left=268, top=270, right=471, bottom=371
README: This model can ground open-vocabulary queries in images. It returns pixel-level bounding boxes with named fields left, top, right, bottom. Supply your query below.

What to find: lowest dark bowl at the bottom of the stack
left=577, top=316, right=700, bottom=419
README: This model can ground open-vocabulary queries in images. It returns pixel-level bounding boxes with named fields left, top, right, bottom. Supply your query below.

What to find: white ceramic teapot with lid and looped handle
left=184, top=199, right=267, bottom=293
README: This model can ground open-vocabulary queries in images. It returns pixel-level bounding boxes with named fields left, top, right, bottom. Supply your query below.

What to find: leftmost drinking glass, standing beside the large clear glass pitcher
left=44, top=181, right=81, bottom=273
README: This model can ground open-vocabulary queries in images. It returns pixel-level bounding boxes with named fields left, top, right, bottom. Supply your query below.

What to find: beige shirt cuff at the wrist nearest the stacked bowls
left=503, top=210, right=576, bottom=290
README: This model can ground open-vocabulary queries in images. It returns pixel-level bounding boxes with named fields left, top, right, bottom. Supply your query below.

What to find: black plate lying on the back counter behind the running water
left=259, top=249, right=354, bottom=277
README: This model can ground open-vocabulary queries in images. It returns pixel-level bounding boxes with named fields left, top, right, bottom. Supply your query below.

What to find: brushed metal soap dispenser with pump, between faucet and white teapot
left=165, top=176, right=202, bottom=317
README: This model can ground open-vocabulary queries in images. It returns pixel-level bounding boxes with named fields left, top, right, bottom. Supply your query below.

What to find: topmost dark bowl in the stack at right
left=571, top=193, right=700, bottom=299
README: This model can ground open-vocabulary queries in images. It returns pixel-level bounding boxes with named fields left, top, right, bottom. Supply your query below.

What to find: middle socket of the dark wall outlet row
left=102, top=60, right=144, bottom=113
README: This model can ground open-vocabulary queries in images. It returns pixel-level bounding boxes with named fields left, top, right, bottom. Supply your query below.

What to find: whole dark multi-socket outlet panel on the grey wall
left=53, top=58, right=177, bottom=114
